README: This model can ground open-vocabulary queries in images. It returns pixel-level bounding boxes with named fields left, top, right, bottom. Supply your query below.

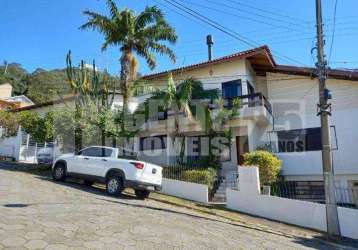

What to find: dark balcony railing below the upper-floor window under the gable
left=224, top=93, right=272, bottom=114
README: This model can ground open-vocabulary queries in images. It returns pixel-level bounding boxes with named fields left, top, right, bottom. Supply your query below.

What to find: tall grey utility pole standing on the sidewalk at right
left=316, top=0, right=340, bottom=237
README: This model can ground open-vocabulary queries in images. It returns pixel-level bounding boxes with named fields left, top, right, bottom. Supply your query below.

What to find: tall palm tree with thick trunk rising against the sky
left=80, top=0, right=177, bottom=113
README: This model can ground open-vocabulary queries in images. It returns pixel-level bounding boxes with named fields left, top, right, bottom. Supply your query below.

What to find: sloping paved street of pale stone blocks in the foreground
left=0, top=167, right=356, bottom=249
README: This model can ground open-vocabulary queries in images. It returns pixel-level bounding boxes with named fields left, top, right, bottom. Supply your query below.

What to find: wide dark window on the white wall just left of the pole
left=277, top=128, right=322, bottom=153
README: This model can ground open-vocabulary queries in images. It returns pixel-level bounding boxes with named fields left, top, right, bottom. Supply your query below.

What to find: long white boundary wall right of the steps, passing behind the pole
left=226, top=167, right=358, bottom=239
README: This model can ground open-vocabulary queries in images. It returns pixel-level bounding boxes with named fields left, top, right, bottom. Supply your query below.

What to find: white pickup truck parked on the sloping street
left=52, top=146, right=162, bottom=199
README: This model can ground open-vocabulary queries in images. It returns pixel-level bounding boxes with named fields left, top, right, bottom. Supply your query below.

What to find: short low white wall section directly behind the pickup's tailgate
left=161, top=178, right=209, bottom=203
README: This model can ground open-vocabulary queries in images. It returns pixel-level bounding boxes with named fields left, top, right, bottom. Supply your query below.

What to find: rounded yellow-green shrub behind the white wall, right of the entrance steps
left=244, top=150, right=282, bottom=185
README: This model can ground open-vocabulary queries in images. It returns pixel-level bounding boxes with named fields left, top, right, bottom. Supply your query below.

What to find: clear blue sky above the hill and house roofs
left=0, top=0, right=358, bottom=74
